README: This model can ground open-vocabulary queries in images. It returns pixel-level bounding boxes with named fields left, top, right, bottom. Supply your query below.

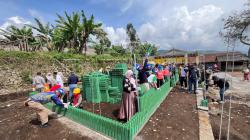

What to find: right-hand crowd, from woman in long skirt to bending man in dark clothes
left=118, top=59, right=234, bottom=121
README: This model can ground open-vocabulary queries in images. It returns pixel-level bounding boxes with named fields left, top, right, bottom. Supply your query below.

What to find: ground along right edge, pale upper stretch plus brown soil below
left=208, top=72, right=250, bottom=140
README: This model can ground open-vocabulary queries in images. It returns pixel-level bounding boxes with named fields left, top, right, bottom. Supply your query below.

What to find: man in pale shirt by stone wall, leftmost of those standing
left=33, top=72, right=45, bottom=92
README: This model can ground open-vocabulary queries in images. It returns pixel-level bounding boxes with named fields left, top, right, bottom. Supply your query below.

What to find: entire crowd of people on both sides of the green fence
left=25, top=59, right=236, bottom=124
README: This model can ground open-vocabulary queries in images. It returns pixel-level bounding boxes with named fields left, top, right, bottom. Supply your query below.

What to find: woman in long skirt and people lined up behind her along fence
left=118, top=59, right=176, bottom=121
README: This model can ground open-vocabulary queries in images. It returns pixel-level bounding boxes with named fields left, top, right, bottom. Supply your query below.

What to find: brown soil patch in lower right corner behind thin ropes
left=210, top=102, right=250, bottom=140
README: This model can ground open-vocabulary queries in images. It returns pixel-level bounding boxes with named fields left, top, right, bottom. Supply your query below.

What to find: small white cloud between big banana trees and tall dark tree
left=104, top=27, right=127, bottom=46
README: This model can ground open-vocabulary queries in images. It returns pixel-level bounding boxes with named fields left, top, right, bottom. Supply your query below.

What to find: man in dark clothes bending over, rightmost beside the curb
left=212, top=76, right=229, bottom=103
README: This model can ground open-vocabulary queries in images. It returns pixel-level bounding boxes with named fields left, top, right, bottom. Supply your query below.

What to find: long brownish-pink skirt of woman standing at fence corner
left=118, top=92, right=136, bottom=121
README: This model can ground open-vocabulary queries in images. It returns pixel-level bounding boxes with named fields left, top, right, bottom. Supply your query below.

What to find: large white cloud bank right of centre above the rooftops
left=138, top=5, right=224, bottom=49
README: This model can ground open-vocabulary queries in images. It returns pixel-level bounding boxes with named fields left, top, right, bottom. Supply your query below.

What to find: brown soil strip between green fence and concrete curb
left=137, top=86, right=199, bottom=140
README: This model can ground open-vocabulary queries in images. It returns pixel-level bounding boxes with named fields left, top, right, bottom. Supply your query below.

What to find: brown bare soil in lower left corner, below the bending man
left=0, top=98, right=90, bottom=140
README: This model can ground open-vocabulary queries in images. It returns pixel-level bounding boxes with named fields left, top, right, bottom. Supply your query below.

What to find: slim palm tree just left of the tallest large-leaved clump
left=28, top=18, right=52, bottom=51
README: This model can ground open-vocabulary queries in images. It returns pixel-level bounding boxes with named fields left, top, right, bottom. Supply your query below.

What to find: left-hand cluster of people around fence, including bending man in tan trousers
left=25, top=72, right=82, bottom=128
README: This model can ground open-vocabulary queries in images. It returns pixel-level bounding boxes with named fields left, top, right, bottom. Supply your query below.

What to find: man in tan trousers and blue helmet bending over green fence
left=25, top=89, right=68, bottom=128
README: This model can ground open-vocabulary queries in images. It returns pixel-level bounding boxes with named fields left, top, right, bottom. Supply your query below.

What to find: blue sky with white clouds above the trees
left=0, top=0, right=248, bottom=53
